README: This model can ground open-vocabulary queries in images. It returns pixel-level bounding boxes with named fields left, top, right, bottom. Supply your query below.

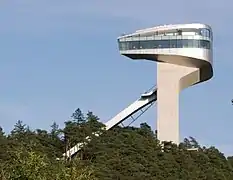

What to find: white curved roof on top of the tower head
left=118, top=23, right=211, bottom=39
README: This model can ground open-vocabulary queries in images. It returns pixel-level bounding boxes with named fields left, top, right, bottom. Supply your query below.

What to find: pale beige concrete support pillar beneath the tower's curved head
left=157, top=62, right=200, bottom=144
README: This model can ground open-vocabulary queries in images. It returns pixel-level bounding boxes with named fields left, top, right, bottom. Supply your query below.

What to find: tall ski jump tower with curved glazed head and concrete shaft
left=118, top=23, right=213, bottom=144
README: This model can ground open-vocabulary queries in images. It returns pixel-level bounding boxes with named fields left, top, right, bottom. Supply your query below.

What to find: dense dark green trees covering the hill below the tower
left=0, top=109, right=233, bottom=180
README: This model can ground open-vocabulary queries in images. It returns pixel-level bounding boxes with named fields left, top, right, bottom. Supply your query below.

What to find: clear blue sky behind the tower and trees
left=0, top=0, right=233, bottom=154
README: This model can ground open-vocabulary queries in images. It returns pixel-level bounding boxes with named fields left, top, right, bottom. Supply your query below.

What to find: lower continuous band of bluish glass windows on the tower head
left=118, top=39, right=211, bottom=50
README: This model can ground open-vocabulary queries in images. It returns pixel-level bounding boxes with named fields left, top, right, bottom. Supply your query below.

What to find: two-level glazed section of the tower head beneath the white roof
left=118, top=28, right=212, bottom=51
